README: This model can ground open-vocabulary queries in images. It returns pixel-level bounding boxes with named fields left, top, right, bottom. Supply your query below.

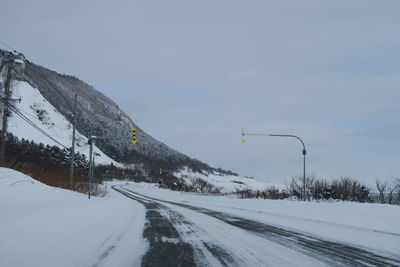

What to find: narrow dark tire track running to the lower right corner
left=123, top=188, right=400, bottom=266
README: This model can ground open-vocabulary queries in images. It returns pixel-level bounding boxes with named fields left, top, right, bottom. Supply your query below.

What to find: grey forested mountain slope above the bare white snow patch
left=14, top=57, right=211, bottom=170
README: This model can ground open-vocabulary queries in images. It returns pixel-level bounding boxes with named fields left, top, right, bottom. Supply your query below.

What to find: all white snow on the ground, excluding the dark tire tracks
left=0, top=168, right=400, bottom=267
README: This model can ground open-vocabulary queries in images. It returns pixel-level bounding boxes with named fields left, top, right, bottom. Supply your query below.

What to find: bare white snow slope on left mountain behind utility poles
left=8, top=82, right=118, bottom=165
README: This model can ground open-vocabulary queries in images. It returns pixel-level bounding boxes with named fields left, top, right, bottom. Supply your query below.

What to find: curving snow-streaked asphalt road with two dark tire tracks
left=114, top=186, right=400, bottom=266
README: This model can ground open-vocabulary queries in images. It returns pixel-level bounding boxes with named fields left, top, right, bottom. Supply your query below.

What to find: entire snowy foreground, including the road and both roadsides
left=0, top=168, right=400, bottom=267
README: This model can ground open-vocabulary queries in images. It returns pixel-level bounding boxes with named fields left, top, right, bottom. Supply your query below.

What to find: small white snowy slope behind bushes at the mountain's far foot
left=174, top=168, right=285, bottom=193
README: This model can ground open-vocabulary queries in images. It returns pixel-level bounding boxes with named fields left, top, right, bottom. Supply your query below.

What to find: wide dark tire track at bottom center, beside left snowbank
left=112, top=186, right=240, bottom=266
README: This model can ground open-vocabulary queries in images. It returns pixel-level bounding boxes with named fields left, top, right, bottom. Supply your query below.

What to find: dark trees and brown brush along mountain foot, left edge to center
left=1, top=133, right=234, bottom=196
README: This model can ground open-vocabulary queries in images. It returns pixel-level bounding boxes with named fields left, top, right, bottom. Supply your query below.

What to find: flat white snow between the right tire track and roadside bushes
left=125, top=183, right=400, bottom=255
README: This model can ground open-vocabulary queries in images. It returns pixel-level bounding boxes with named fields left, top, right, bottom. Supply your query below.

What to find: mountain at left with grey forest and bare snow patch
left=0, top=49, right=233, bottom=178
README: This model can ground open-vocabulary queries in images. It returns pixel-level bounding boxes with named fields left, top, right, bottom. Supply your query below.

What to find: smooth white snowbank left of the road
left=0, top=168, right=147, bottom=267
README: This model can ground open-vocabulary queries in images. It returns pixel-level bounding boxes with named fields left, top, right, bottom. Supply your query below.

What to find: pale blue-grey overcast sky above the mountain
left=0, top=0, right=400, bottom=185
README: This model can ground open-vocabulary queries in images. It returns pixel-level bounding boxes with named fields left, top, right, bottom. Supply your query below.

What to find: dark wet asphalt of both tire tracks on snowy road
left=113, top=186, right=400, bottom=266
